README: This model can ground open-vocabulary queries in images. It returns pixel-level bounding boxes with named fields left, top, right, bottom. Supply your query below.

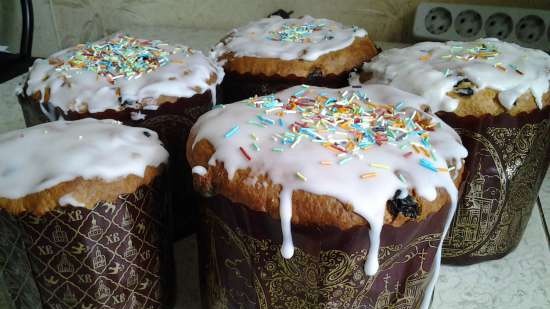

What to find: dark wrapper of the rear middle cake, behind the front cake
left=221, top=71, right=356, bottom=104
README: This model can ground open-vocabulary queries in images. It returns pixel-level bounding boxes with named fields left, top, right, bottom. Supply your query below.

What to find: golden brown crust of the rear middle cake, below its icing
left=220, top=36, right=378, bottom=77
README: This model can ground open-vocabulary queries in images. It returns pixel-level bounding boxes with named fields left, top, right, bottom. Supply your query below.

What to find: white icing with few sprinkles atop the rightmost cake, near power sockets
left=363, top=39, right=550, bottom=112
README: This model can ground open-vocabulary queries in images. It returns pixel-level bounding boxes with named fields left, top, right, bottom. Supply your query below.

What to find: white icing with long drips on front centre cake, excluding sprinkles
left=192, top=85, right=467, bottom=288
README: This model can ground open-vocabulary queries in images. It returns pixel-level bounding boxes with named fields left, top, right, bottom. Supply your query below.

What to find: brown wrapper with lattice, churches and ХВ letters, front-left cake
left=15, top=176, right=173, bottom=309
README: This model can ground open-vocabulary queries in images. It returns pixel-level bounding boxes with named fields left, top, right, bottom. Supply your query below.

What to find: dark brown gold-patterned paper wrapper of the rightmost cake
left=438, top=107, right=550, bottom=265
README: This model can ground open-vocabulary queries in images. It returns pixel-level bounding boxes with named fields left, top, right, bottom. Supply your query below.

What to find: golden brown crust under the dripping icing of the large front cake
left=187, top=136, right=462, bottom=230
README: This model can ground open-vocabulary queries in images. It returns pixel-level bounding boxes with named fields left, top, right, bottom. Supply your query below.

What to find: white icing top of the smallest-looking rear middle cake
left=214, top=16, right=367, bottom=61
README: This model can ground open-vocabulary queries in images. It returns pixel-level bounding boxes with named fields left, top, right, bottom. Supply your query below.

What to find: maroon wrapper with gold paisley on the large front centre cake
left=201, top=208, right=441, bottom=309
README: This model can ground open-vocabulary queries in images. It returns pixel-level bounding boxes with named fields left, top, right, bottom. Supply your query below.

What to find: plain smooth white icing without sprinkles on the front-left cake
left=0, top=119, right=168, bottom=199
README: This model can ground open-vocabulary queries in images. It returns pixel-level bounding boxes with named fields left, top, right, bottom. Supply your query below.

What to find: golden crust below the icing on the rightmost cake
left=447, top=88, right=550, bottom=117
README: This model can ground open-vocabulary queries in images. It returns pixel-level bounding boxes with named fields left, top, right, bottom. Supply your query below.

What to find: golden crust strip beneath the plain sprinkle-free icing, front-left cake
left=0, top=166, right=164, bottom=216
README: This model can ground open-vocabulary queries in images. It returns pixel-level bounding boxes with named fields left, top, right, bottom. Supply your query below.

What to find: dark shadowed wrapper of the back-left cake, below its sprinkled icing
left=19, top=90, right=217, bottom=238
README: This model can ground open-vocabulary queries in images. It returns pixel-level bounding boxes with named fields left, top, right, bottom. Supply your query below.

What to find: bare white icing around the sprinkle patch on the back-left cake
left=26, top=34, right=224, bottom=120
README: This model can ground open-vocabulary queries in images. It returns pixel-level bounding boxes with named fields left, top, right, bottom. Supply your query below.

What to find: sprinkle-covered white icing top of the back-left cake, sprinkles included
left=26, top=34, right=224, bottom=120
